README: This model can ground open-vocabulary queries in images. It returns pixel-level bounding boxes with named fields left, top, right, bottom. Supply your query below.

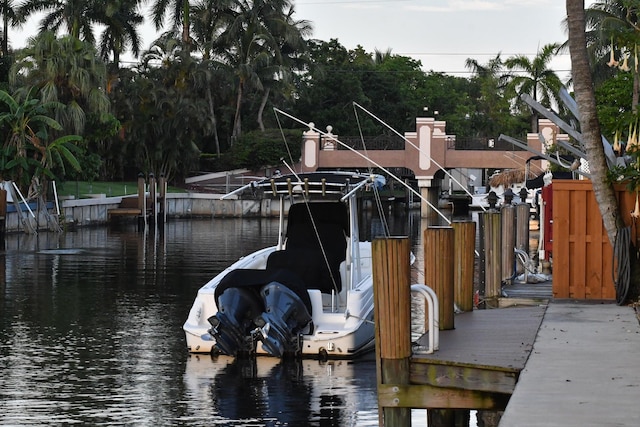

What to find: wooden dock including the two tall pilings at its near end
left=372, top=227, right=552, bottom=427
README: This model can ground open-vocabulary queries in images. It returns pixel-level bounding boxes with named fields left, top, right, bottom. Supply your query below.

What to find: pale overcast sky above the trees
left=12, top=0, right=592, bottom=78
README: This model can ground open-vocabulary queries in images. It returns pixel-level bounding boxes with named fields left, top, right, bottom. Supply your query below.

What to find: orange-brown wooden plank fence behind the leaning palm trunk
left=552, top=180, right=639, bottom=300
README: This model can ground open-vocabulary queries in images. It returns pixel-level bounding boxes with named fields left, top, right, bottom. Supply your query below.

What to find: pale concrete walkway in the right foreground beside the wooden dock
left=499, top=301, right=640, bottom=427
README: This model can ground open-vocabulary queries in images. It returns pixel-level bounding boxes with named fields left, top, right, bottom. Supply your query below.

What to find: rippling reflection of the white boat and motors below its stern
left=184, top=354, right=378, bottom=426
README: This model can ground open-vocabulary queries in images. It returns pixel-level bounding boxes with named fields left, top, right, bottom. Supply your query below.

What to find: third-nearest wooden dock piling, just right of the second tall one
left=451, top=221, right=476, bottom=311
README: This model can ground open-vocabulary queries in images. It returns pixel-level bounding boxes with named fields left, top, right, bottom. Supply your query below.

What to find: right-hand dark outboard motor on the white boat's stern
left=255, top=282, right=311, bottom=357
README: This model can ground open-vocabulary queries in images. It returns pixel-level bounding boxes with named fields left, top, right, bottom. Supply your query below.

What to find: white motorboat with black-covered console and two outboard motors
left=183, top=172, right=388, bottom=358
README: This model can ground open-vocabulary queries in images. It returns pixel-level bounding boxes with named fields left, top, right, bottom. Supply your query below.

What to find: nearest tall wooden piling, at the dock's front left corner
left=372, top=237, right=411, bottom=427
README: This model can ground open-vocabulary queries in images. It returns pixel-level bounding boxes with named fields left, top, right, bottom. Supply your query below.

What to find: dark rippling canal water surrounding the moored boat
left=0, top=215, right=450, bottom=427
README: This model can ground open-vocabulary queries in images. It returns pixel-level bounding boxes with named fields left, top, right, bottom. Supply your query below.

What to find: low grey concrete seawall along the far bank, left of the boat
left=5, top=193, right=278, bottom=232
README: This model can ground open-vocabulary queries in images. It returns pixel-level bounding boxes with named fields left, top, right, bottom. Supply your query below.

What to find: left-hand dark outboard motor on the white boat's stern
left=207, top=288, right=264, bottom=356
